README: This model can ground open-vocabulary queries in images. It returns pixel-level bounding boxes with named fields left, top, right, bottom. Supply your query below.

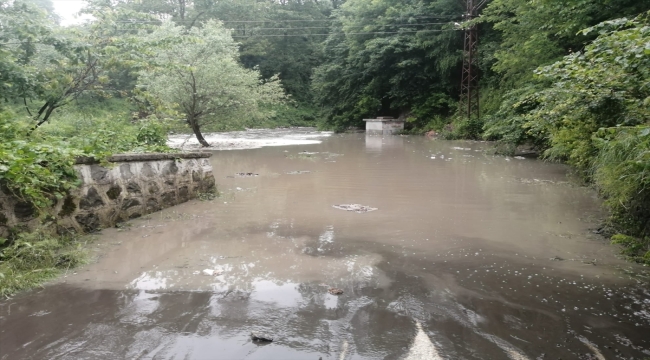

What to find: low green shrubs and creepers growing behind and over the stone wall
left=0, top=102, right=171, bottom=210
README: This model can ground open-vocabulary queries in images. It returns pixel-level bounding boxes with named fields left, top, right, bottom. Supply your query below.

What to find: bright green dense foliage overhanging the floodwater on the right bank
left=484, top=9, right=650, bottom=262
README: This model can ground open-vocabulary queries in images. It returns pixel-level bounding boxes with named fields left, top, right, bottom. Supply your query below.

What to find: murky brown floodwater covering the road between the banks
left=0, top=134, right=650, bottom=360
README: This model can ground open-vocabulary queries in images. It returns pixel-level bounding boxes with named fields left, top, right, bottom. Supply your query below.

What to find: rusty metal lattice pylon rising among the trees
left=459, top=0, right=487, bottom=119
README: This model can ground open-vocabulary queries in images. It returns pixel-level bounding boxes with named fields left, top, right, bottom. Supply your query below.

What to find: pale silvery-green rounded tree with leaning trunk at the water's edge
left=139, top=21, right=286, bottom=146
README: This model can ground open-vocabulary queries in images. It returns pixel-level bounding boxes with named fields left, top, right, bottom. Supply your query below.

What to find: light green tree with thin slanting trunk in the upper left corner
left=0, top=1, right=150, bottom=131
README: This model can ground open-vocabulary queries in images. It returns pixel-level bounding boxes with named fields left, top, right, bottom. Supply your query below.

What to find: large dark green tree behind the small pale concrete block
left=313, top=0, right=462, bottom=129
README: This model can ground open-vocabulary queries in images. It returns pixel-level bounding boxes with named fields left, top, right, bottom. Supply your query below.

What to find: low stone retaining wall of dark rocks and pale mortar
left=0, top=153, right=215, bottom=237
